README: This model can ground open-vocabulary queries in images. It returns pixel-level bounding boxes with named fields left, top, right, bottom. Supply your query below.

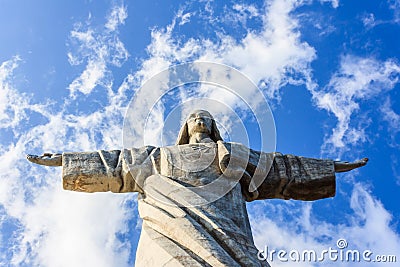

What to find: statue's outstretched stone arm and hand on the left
left=26, top=149, right=154, bottom=193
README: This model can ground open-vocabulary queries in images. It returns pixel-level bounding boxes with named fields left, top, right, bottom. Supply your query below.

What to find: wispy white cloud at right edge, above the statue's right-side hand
left=311, top=55, right=400, bottom=156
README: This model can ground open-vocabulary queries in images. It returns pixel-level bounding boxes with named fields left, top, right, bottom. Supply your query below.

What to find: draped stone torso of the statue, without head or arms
left=137, top=143, right=259, bottom=266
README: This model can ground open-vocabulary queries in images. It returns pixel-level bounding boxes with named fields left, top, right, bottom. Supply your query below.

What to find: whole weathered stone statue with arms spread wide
left=27, top=110, right=368, bottom=266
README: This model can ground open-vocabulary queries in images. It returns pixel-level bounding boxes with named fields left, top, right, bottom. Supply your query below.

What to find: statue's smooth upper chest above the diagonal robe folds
left=160, top=143, right=222, bottom=186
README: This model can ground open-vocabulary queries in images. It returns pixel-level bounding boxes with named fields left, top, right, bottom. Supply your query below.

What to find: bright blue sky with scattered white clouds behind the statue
left=0, top=0, right=400, bottom=266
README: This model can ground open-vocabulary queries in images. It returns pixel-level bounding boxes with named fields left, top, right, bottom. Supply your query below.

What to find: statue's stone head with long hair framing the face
left=176, top=110, right=222, bottom=145
